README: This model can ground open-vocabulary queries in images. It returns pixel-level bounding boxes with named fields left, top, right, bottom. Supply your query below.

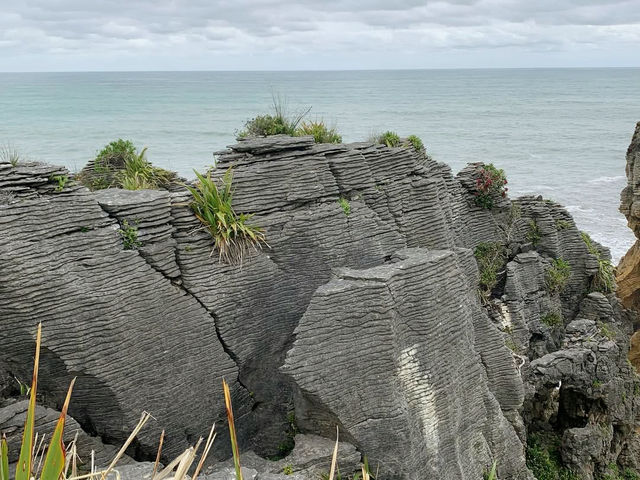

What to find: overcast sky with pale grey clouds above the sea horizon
left=0, top=0, right=640, bottom=71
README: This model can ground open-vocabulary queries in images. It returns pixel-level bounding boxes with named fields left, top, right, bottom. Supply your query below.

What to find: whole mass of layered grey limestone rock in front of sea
left=0, top=136, right=637, bottom=480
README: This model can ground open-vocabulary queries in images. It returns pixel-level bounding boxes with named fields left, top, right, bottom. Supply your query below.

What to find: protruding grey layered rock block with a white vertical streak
left=283, top=249, right=526, bottom=479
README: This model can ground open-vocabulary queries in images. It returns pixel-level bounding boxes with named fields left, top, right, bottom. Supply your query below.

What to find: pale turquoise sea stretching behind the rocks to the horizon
left=0, top=69, right=640, bottom=259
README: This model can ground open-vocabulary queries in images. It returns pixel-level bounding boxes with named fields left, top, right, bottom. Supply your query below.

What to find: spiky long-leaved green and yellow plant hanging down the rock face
left=185, top=167, right=267, bottom=264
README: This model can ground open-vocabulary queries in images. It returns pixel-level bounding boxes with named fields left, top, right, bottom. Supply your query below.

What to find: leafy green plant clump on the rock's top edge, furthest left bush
left=77, top=138, right=176, bottom=190
